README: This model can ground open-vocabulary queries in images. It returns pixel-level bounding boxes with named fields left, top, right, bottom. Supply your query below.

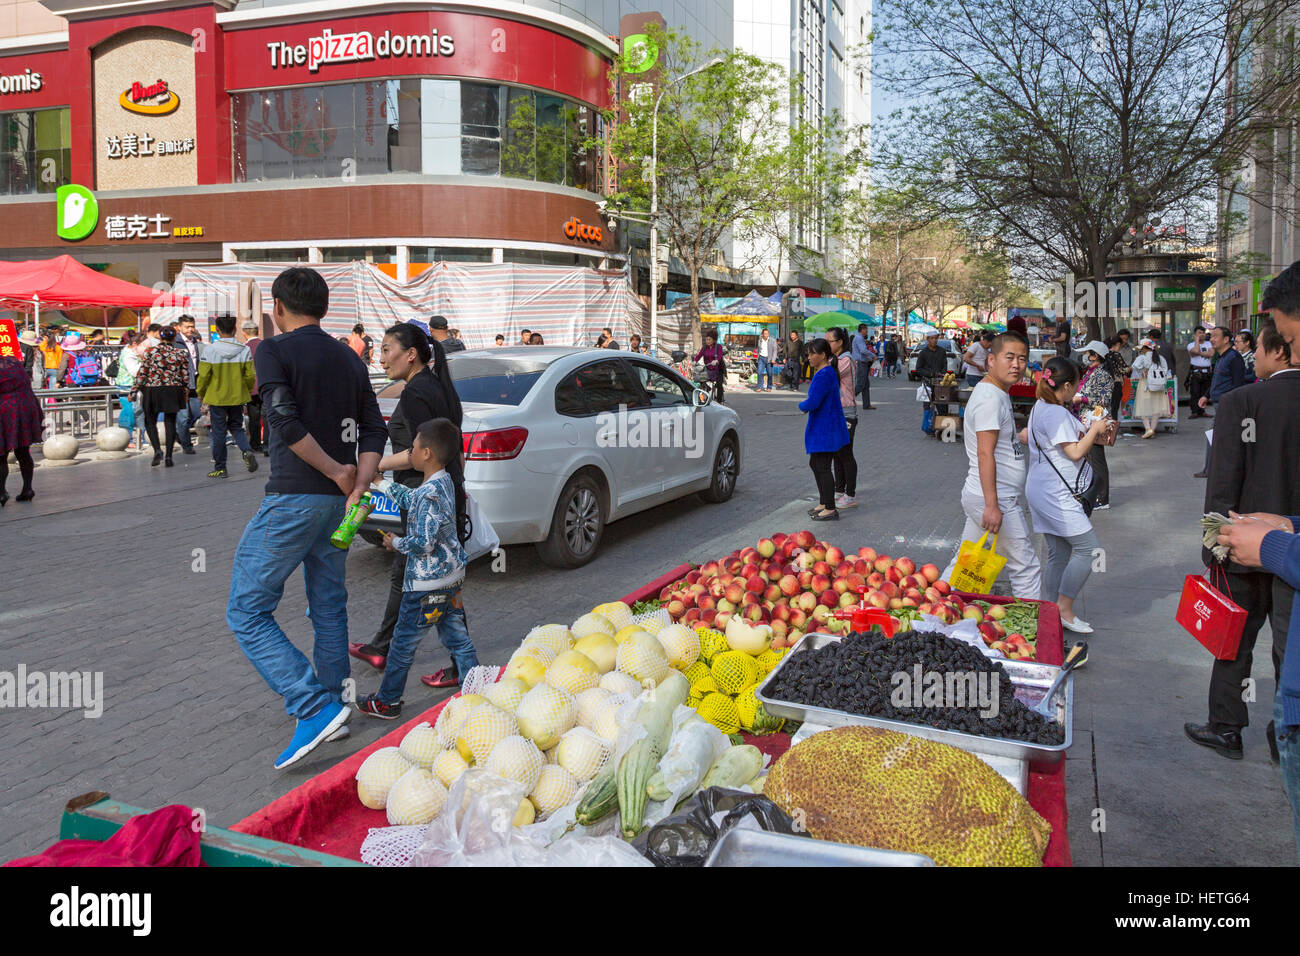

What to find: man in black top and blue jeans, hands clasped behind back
left=226, top=267, right=387, bottom=770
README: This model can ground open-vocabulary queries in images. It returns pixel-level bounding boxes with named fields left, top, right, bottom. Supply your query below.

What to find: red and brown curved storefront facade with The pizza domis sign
left=0, top=0, right=616, bottom=290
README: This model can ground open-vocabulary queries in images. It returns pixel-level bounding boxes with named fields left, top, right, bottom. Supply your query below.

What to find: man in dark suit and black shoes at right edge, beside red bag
left=1183, top=329, right=1300, bottom=760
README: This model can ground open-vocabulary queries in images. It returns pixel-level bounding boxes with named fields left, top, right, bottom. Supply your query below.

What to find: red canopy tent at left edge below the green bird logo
left=0, top=255, right=190, bottom=328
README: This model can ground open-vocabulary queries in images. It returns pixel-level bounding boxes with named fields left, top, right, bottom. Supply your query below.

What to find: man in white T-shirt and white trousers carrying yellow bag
left=943, top=332, right=1043, bottom=601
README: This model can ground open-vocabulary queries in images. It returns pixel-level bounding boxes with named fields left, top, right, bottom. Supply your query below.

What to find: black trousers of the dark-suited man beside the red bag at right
left=1209, top=571, right=1295, bottom=734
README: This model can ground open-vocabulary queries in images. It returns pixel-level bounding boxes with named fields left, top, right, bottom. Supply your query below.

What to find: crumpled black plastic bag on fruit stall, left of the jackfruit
left=632, top=787, right=807, bottom=866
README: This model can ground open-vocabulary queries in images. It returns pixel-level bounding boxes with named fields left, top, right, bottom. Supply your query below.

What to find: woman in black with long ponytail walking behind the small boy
left=348, top=323, right=468, bottom=687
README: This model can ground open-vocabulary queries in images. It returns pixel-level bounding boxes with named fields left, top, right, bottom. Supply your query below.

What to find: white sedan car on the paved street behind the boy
left=365, top=346, right=742, bottom=567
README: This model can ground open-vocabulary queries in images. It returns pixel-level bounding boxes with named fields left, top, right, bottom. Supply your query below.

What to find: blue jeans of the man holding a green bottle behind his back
left=226, top=494, right=350, bottom=719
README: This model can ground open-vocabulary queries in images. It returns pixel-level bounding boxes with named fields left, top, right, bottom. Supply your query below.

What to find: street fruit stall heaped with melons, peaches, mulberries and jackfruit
left=233, top=532, right=1073, bottom=865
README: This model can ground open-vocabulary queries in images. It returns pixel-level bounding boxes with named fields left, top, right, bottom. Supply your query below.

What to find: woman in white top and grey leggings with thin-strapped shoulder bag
left=1024, top=356, right=1106, bottom=633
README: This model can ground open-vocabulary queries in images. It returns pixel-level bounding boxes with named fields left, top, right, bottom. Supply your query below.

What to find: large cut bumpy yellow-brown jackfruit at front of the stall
left=763, top=727, right=1052, bottom=866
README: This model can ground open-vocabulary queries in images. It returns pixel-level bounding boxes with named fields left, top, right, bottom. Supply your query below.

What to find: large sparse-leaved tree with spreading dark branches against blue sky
left=874, top=0, right=1300, bottom=337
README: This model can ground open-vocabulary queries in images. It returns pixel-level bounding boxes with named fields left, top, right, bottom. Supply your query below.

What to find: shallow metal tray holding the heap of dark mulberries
left=754, top=633, right=1074, bottom=763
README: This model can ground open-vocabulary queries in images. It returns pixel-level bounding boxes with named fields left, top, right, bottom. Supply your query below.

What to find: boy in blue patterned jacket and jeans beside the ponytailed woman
left=356, top=419, right=478, bottom=721
